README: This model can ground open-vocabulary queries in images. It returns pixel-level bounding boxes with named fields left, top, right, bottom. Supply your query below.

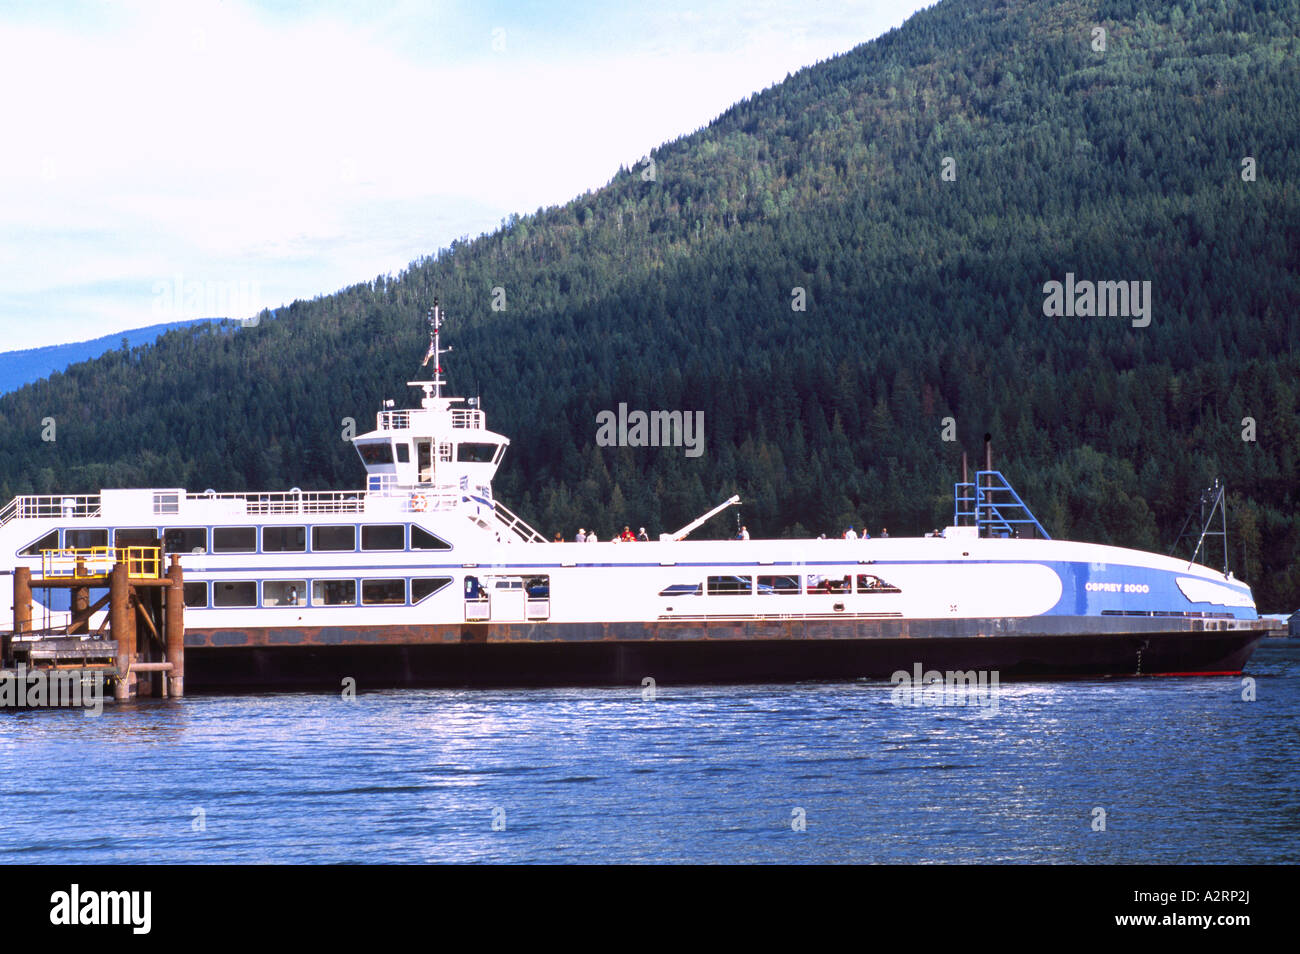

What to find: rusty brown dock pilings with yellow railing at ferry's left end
left=0, top=547, right=185, bottom=701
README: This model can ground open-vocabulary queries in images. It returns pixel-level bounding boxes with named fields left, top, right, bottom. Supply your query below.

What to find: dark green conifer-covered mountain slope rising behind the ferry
left=0, top=0, right=1300, bottom=611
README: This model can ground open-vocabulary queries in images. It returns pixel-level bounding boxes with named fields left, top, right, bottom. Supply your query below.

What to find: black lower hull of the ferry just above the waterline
left=185, top=629, right=1264, bottom=691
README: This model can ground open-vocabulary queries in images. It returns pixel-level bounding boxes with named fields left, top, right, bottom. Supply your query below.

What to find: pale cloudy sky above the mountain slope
left=0, top=0, right=928, bottom=351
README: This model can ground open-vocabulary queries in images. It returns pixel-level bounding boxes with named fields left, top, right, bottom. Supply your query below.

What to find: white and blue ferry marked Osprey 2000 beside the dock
left=0, top=305, right=1264, bottom=691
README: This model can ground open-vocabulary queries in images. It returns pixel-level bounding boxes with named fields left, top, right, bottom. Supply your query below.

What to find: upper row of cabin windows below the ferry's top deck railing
left=20, top=524, right=451, bottom=556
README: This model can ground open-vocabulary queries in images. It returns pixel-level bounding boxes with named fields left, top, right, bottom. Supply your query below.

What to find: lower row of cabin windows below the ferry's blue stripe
left=185, top=576, right=451, bottom=610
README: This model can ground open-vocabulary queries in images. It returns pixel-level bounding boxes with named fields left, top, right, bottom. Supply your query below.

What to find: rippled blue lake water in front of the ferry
left=0, top=639, right=1300, bottom=863
